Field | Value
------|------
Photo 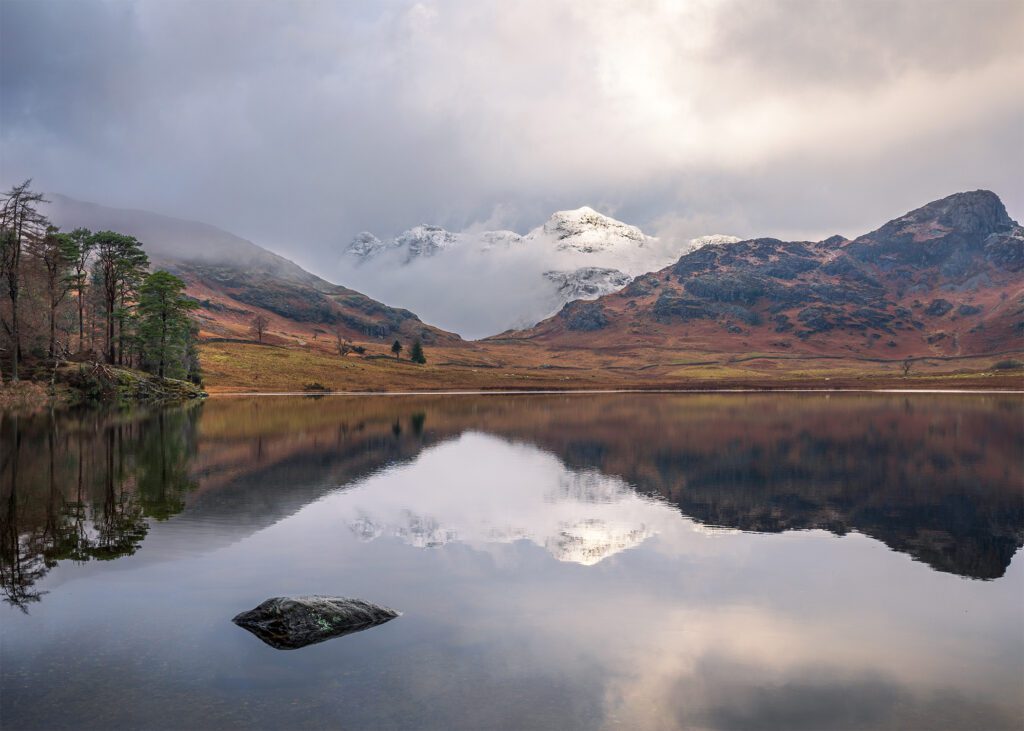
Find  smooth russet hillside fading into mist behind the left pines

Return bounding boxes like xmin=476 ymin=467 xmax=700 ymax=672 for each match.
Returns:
xmin=46 ymin=196 xmax=461 ymax=343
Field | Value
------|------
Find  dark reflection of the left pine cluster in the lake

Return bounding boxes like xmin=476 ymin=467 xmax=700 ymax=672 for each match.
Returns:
xmin=0 ymin=405 xmax=202 ymax=611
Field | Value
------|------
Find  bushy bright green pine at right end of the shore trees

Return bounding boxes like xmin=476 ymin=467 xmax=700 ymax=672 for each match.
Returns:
xmin=137 ymin=270 xmax=197 ymax=378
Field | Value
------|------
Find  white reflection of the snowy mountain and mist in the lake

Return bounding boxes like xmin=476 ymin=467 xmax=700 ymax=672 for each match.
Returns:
xmin=346 ymin=432 xmax=663 ymax=566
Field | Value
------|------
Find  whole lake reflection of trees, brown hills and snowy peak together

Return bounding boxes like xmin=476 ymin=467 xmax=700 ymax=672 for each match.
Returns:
xmin=0 ymin=394 xmax=1024 ymax=606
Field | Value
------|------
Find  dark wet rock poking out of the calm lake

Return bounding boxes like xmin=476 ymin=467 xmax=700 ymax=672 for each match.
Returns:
xmin=231 ymin=597 xmax=399 ymax=650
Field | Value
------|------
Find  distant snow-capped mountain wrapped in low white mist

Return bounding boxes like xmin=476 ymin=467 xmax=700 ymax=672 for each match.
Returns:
xmin=343 ymin=206 xmax=738 ymax=334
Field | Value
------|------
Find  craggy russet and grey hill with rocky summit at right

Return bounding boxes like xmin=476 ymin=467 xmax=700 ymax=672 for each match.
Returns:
xmin=504 ymin=190 xmax=1024 ymax=358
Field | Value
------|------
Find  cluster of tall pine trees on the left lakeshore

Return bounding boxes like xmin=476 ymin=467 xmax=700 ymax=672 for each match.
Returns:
xmin=0 ymin=180 xmax=200 ymax=382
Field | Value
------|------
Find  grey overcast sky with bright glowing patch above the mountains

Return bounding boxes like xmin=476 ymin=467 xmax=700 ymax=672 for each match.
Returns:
xmin=0 ymin=0 xmax=1024 ymax=274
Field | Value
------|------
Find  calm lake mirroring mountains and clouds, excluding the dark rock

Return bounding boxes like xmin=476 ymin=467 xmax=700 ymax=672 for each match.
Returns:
xmin=0 ymin=393 xmax=1024 ymax=730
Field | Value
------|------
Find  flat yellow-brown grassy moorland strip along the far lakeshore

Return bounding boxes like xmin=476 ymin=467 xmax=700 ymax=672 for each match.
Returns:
xmin=200 ymin=341 xmax=1024 ymax=393
